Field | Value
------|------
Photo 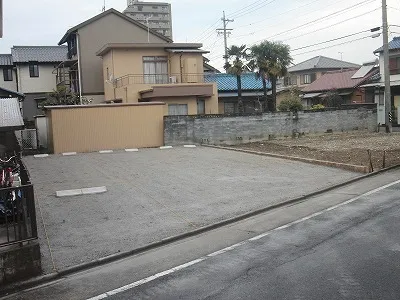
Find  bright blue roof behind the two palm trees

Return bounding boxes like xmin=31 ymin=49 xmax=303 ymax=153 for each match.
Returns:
xmin=204 ymin=73 xmax=271 ymax=92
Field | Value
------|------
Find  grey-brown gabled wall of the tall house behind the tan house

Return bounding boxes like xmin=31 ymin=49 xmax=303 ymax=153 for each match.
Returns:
xmin=78 ymin=14 xmax=166 ymax=95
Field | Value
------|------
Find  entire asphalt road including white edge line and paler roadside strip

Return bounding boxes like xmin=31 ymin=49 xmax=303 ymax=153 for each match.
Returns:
xmin=5 ymin=171 xmax=400 ymax=300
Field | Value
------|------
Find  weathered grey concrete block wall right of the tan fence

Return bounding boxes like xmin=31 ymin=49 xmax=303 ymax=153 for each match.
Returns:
xmin=164 ymin=108 xmax=377 ymax=145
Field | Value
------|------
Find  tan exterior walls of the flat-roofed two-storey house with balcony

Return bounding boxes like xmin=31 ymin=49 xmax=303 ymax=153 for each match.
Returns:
xmin=103 ymin=49 xmax=218 ymax=114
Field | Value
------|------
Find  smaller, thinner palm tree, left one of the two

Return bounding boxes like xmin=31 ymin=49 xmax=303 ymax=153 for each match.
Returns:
xmin=224 ymin=45 xmax=249 ymax=113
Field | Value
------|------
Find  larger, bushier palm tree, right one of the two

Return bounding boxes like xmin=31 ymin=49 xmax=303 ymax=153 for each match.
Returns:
xmin=251 ymin=41 xmax=293 ymax=111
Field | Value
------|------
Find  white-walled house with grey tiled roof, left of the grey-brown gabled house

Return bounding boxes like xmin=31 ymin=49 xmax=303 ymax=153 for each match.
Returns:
xmin=11 ymin=46 xmax=67 ymax=121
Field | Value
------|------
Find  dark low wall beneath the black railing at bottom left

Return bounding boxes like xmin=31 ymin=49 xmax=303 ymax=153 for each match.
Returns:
xmin=0 ymin=241 xmax=42 ymax=286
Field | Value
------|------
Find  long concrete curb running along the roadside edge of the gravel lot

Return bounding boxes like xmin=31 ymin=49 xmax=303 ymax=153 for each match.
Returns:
xmin=0 ymin=165 xmax=400 ymax=297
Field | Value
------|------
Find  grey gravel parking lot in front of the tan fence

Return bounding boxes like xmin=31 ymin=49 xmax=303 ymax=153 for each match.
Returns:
xmin=24 ymin=147 xmax=358 ymax=273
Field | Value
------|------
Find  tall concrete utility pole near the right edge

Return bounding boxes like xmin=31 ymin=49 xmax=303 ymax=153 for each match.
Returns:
xmin=382 ymin=0 xmax=392 ymax=133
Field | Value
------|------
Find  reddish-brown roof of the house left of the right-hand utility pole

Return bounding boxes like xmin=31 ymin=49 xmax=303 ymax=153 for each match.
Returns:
xmin=302 ymin=68 xmax=378 ymax=93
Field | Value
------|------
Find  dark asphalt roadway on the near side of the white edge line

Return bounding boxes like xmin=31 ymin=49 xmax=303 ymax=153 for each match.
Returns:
xmin=101 ymin=180 xmax=400 ymax=300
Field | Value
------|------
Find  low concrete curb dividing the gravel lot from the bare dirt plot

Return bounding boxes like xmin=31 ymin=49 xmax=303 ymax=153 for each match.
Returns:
xmin=202 ymin=145 xmax=369 ymax=174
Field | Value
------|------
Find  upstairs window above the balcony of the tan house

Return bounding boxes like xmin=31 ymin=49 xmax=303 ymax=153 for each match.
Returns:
xmin=143 ymin=56 xmax=168 ymax=83
